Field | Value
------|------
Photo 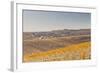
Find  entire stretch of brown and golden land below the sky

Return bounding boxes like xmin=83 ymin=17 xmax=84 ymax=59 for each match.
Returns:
xmin=23 ymin=29 xmax=91 ymax=62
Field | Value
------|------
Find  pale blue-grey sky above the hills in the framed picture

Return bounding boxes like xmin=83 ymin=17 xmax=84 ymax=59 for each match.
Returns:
xmin=23 ymin=10 xmax=91 ymax=32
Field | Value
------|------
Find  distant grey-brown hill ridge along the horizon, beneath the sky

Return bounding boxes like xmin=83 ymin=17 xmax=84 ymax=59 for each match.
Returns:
xmin=23 ymin=29 xmax=91 ymax=38
